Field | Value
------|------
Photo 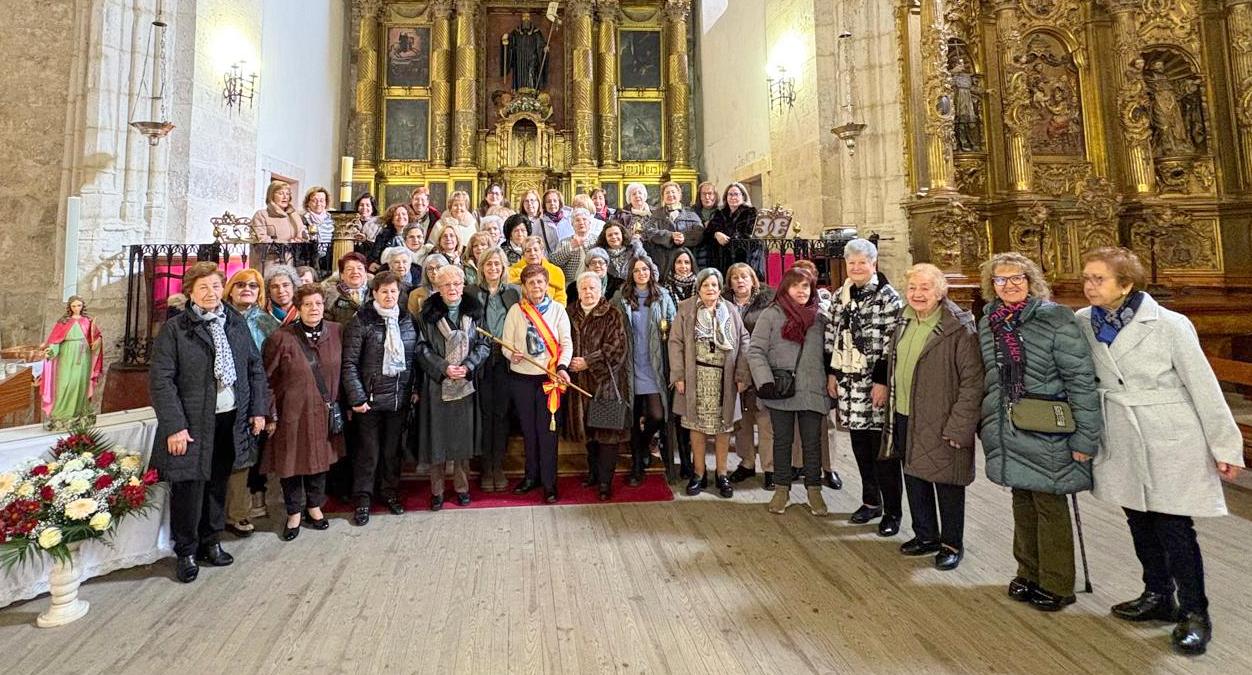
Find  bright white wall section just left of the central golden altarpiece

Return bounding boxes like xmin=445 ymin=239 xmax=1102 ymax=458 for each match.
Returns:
xmin=255 ymin=0 xmax=349 ymax=207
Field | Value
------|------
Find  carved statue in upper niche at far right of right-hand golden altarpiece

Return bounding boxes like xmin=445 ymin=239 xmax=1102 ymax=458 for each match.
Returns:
xmin=1143 ymin=60 xmax=1208 ymax=157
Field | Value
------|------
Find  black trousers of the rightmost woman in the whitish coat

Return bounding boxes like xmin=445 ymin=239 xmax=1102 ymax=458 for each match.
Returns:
xmin=1123 ymin=508 xmax=1208 ymax=612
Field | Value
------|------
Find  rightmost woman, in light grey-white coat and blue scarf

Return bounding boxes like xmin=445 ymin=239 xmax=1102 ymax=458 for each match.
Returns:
xmin=1078 ymin=248 xmax=1243 ymax=655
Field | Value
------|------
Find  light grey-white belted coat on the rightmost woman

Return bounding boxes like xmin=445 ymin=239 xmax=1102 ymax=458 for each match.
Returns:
xmin=1078 ymin=294 xmax=1243 ymax=517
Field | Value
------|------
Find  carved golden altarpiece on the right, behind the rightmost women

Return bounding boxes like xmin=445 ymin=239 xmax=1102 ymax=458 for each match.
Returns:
xmin=896 ymin=0 xmax=1252 ymax=348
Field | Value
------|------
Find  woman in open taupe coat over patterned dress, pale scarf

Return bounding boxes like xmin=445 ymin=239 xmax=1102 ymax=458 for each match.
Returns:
xmin=669 ymin=268 xmax=751 ymax=498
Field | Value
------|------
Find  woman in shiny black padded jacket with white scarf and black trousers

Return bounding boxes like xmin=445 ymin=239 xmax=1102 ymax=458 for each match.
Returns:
xmin=342 ymin=272 xmax=417 ymax=526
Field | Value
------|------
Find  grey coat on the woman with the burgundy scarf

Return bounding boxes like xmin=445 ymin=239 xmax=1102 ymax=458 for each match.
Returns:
xmin=747 ymin=304 xmax=830 ymax=415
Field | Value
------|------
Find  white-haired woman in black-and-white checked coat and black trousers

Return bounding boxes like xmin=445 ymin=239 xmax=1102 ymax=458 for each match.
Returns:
xmin=826 ymin=239 xmax=904 ymax=537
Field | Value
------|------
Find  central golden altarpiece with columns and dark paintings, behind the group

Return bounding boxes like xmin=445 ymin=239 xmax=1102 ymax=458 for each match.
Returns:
xmin=346 ymin=0 xmax=696 ymax=208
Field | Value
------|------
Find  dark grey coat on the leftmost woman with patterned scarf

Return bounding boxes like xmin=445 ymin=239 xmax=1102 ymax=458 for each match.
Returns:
xmin=148 ymin=306 xmax=269 ymax=482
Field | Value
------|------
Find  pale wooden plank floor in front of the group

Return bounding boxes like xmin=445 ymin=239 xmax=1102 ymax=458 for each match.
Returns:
xmin=0 ymin=437 xmax=1252 ymax=675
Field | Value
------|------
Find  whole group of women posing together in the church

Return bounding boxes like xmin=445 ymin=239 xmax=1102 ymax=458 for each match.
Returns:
xmin=151 ymin=184 xmax=1242 ymax=654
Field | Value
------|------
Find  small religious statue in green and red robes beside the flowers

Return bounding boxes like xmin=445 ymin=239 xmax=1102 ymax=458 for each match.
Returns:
xmin=39 ymin=296 xmax=104 ymax=430
